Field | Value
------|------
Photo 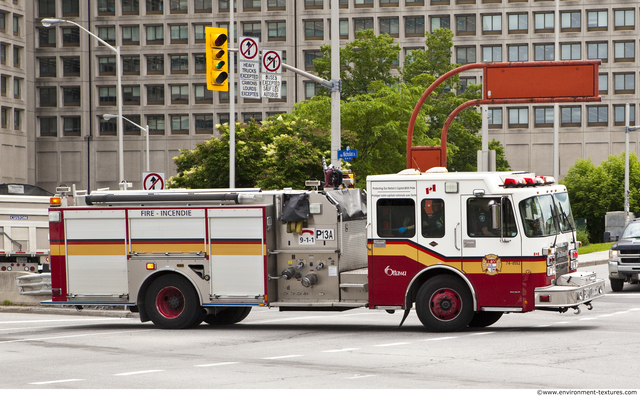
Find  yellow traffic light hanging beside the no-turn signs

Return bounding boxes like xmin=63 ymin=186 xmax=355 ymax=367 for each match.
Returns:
xmin=205 ymin=26 xmax=229 ymax=92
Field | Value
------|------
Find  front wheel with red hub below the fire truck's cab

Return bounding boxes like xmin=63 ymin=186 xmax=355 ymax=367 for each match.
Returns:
xmin=416 ymin=275 xmax=474 ymax=332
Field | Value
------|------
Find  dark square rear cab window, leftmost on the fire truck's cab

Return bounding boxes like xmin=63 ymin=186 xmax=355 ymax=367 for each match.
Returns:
xmin=377 ymin=198 xmax=416 ymax=238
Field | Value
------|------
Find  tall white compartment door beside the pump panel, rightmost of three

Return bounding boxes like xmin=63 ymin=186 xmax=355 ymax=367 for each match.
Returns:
xmin=207 ymin=208 xmax=266 ymax=301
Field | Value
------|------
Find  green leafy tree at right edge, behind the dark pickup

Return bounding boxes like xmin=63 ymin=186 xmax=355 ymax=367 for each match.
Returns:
xmin=560 ymin=153 xmax=640 ymax=242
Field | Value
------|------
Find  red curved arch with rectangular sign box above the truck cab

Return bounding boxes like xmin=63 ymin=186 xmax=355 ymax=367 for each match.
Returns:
xmin=407 ymin=60 xmax=601 ymax=171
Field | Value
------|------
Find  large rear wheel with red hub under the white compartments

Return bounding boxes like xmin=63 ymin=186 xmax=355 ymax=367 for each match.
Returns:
xmin=145 ymin=274 xmax=203 ymax=329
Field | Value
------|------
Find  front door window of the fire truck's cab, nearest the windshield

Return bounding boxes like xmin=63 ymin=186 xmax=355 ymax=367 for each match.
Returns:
xmin=467 ymin=198 xmax=518 ymax=238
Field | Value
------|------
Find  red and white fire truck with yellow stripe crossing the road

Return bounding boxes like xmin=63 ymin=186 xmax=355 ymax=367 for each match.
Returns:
xmin=45 ymin=168 xmax=604 ymax=332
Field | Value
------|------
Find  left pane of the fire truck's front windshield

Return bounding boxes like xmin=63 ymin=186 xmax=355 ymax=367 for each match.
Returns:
xmin=520 ymin=195 xmax=568 ymax=237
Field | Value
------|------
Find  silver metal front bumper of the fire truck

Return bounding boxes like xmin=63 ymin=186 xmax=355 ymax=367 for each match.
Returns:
xmin=534 ymin=274 xmax=604 ymax=310
